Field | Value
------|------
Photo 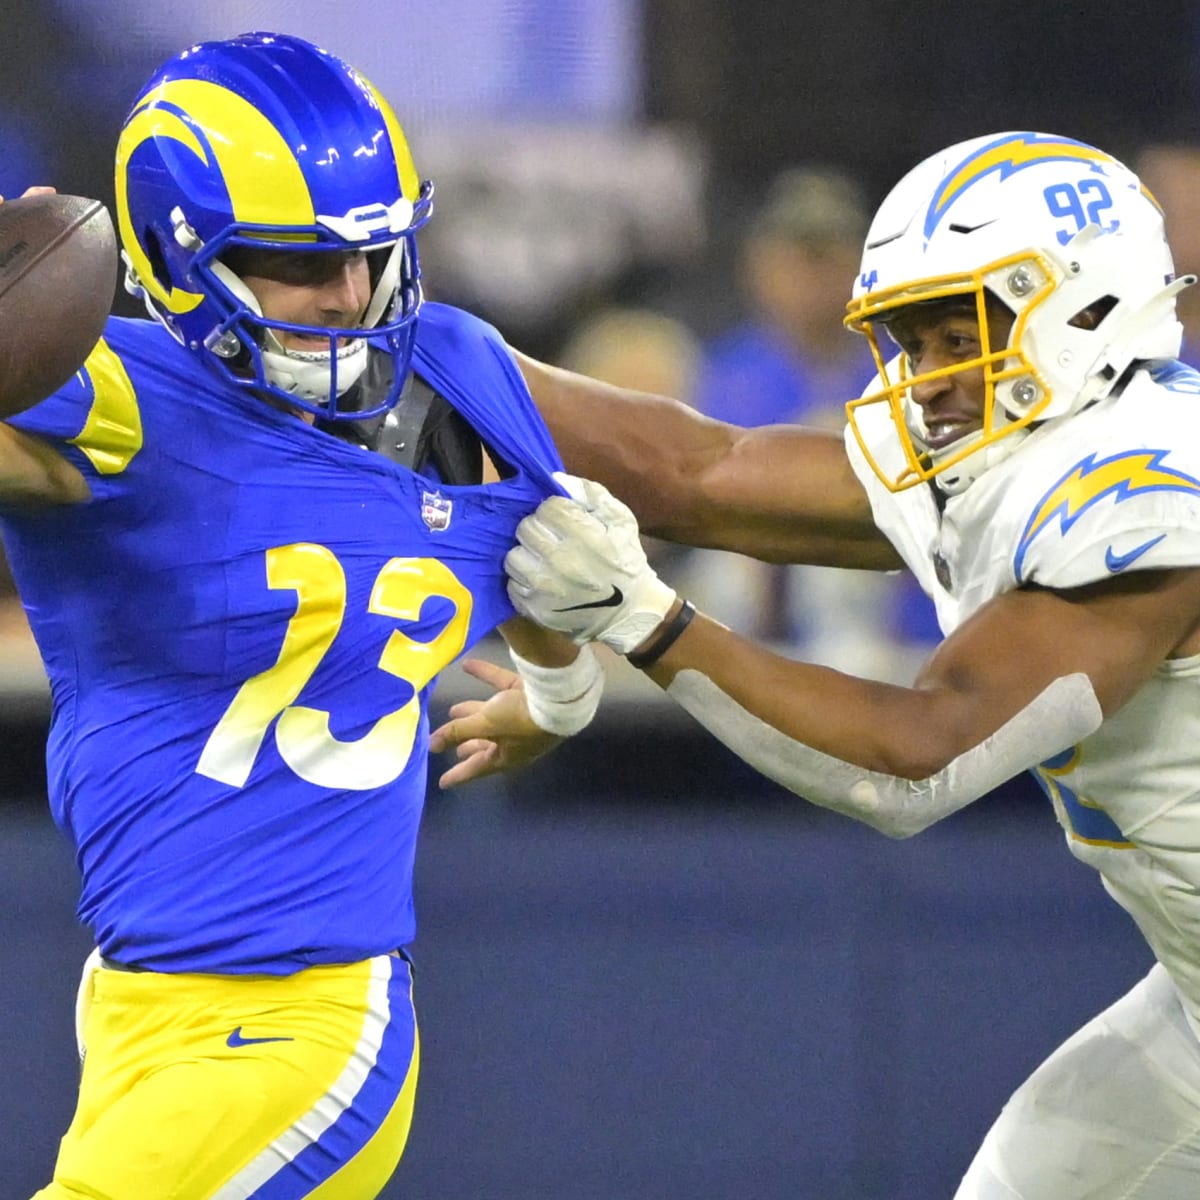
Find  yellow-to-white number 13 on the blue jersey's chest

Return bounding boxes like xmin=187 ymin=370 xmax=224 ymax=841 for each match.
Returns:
xmin=196 ymin=542 xmax=472 ymax=790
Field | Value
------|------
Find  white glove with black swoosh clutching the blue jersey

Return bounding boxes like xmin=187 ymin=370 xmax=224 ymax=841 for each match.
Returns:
xmin=504 ymin=474 xmax=676 ymax=654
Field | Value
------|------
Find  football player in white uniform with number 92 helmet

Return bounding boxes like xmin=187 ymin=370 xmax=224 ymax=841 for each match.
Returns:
xmin=434 ymin=133 xmax=1200 ymax=1200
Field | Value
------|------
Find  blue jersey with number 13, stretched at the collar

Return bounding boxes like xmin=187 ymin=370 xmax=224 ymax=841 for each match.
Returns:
xmin=2 ymin=305 xmax=560 ymax=973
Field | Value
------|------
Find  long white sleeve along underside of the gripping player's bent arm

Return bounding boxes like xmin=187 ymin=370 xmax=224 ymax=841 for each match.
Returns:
xmin=667 ymin=671 xmax=1104 ymax=838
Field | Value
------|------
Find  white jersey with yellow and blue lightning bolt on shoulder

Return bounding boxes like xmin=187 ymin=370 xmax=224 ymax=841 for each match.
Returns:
xmin=846 ymin=362 xmax=1200 ymax=1022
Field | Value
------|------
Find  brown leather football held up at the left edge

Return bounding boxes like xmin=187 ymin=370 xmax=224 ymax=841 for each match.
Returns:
xmin=0 ymin=194 xmax=116 ymax=418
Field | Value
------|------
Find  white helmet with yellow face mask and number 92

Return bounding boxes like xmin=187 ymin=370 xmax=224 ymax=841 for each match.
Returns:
xmin=846 ymin=132 xmax=1195 ymax=494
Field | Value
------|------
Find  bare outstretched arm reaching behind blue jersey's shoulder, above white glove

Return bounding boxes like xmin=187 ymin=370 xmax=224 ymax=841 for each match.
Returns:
xmin=515 ymin=354 xmax=901 ymax=570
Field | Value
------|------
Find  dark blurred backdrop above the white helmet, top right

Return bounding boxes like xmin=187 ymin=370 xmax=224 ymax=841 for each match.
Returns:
xmin=647 ymin=0 xmax=1200 ymax=198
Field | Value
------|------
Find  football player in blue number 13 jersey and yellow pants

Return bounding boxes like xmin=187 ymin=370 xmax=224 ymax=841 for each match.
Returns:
xmin=0 ymin=34 xmax=601 ymax=1200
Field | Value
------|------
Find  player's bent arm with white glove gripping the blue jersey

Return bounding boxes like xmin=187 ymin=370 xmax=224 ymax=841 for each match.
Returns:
xmin=489 ymin=485 xmax=1200 ymax=836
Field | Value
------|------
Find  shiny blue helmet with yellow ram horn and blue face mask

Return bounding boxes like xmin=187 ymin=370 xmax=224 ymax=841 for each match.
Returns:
xmin=116 ymin=34 xmax=432 ymax=420
